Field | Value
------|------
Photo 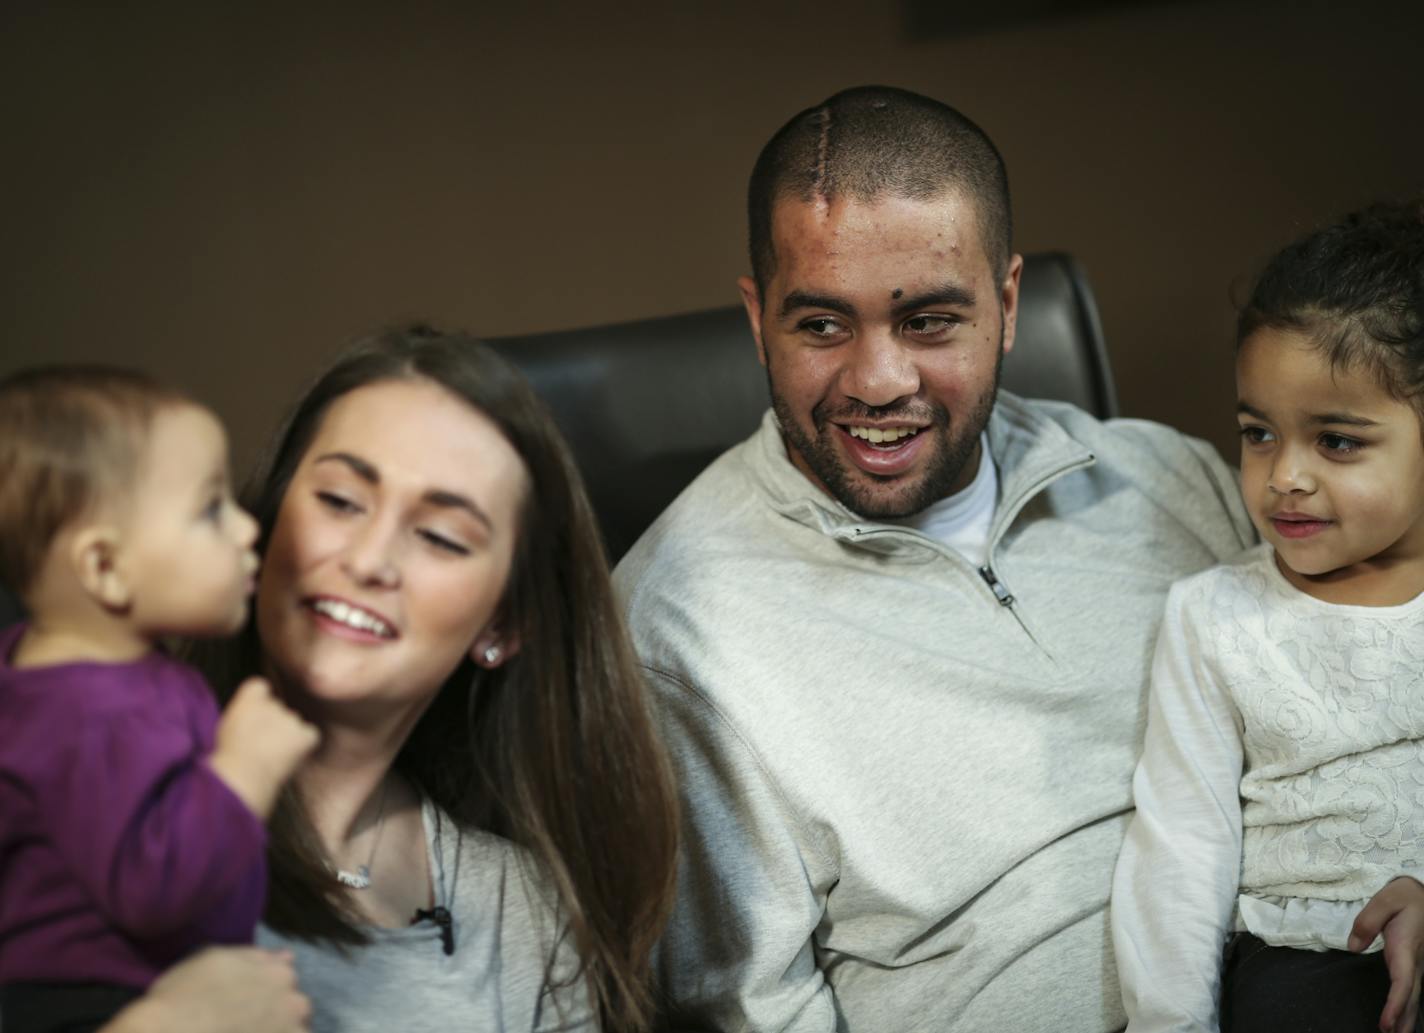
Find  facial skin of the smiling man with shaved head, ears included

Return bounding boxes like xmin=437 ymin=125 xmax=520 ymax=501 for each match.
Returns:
xmin=738 ymin=191 xmax=1022 ymax=519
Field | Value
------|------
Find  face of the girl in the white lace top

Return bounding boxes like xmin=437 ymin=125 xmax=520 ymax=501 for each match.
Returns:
xmin=1236 ymin=331 xmax=1424 ymax=601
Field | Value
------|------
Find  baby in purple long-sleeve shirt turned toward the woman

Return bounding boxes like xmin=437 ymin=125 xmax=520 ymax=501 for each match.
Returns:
xmin=0 ymin=368 xmax=316 ymax=1033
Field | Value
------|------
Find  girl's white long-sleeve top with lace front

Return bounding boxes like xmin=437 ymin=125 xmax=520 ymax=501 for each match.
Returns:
xmin=1112 ymin=546 xmax=1424 ymax=1032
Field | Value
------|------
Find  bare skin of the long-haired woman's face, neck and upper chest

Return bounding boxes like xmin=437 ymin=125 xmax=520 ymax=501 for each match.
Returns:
xmin=256 ymin=380 xmax=528 ymax=928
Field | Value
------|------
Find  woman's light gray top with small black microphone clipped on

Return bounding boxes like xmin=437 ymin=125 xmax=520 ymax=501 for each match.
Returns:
xmin=258 ymin=801 xmax=598 ymax=1033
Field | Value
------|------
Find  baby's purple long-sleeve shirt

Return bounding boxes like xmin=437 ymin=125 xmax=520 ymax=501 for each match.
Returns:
xmin=0 ymin=625 xmax=266 ymax=987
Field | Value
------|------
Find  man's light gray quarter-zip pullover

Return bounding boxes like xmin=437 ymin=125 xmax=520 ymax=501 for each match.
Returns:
xmin=617 ymin=393 xmax=1255 ymax=1033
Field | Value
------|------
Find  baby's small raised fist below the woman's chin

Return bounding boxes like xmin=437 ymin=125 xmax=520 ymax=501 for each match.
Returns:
xmin=208 ymin=678 xmax=320 ymax=821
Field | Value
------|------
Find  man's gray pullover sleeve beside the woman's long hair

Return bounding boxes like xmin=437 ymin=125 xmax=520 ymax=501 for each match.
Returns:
xmin=649 ymin=671 xmax=836 ymax=1033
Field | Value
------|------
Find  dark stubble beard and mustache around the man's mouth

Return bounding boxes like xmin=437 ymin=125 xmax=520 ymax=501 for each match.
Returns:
xmin=766 ymin=346 xmax=1004 ymax=520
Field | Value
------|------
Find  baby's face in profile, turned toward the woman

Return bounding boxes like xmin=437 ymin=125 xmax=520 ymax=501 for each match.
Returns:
xmin=118 ymin=405 xmax=258 ymax=638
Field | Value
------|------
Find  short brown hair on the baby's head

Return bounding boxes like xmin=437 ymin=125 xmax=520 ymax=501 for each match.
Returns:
xmin=0 ymin=366 xmax=192 ymax=597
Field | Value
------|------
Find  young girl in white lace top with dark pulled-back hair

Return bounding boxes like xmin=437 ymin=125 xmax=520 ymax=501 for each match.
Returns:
xmin=1112 ymin=202 xmax=1424 ymax=1033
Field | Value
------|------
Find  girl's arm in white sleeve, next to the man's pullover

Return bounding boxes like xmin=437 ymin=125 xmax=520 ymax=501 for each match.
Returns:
xmin=1111 ymin=586 xmax=1242 ymax=1033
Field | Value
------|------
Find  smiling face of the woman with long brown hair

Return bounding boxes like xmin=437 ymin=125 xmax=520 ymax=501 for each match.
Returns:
xmin=256 ymin=380 xmax=528 ymax=720
